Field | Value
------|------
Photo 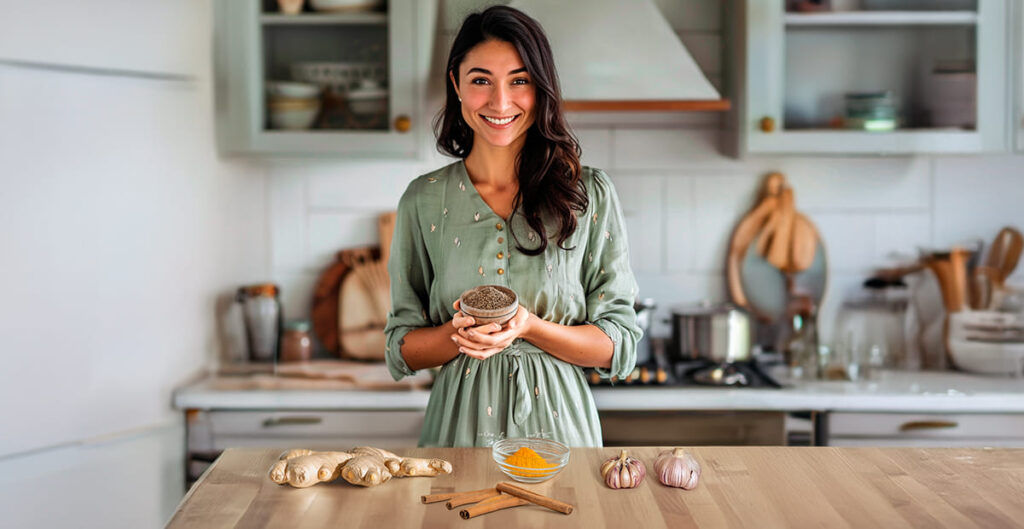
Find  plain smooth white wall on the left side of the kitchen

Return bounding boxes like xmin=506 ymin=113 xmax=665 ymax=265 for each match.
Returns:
xmin=0 ymin=0 xmax=268 ymax=528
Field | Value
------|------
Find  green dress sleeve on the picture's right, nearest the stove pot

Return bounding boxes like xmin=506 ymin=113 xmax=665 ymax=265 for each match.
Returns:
xmin=581 ymin=169 xmax=643 ymax=379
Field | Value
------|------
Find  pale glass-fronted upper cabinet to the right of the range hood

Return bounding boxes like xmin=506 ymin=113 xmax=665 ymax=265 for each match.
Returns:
xmin=730 ymin=0 xmax=1013 ymax=156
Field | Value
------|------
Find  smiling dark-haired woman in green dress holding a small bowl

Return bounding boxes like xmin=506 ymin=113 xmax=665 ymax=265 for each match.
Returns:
xmin=385 ymin=6 xmax=640 ymax=446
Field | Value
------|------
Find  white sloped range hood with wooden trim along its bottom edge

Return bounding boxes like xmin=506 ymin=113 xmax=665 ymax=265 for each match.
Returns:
xmin=509 ymin=0 xmax=729 ymax=112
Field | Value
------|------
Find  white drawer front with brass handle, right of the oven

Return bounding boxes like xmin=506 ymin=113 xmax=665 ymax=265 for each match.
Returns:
xmin=828 ymin=413 xmax=1024 ymax=444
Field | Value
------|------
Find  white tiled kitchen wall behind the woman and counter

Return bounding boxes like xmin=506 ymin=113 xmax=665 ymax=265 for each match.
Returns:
xmin=269 ymin=0 xmax=1024 ymax=340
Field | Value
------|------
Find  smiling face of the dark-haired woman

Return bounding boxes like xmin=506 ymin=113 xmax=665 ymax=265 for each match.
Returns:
xmin=450 ymin=40 xmax=537 ymax=147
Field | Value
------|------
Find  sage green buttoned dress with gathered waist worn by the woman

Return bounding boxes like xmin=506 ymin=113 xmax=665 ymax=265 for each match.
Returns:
xmin=384 ymin=161 xmax=641 ymax=446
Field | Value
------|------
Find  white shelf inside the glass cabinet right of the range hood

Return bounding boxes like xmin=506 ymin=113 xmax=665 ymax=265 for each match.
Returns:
xmin=784 ymin=11 xmax=978 ymax=28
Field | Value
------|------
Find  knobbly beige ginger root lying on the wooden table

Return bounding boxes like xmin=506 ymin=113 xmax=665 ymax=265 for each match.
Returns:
xmin=270 ymin=446 xmax=452 ymax=488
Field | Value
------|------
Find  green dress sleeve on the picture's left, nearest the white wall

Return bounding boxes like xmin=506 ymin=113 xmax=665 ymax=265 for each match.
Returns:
xmin=384 ymin=181 xmax=433 ymax=381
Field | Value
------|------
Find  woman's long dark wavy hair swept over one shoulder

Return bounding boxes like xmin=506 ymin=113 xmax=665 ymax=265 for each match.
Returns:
xmin=434 ymin=5 xmax=588 ymax=256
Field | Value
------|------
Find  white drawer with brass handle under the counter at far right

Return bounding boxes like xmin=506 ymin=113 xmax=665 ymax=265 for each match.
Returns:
xmin=827 ymin=412 xmax=1024 ymax=447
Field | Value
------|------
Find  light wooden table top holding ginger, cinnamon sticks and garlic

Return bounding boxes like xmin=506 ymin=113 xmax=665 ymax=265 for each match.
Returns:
xmin=169 ymin=447 xmax=1024 ymax=529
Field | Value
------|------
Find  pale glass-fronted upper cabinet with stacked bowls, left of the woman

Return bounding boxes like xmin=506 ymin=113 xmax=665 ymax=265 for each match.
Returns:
xmin=214 ymin=0 xmax=425 ymax=158
